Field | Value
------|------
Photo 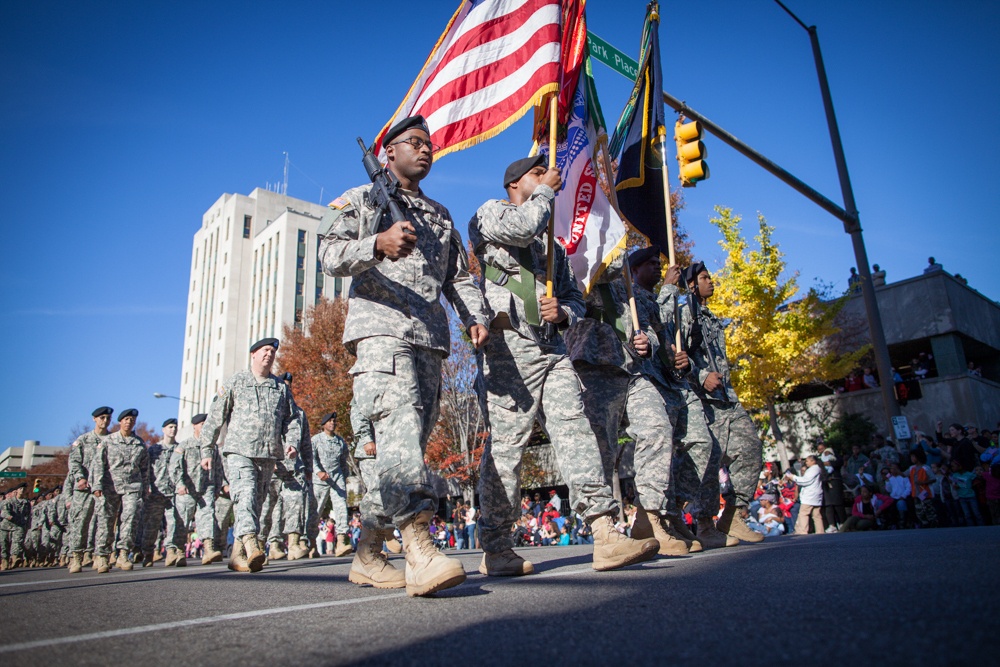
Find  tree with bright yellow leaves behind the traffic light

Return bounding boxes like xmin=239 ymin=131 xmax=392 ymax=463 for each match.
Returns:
xmin=709 ymin=206 xmax=867 ymax=468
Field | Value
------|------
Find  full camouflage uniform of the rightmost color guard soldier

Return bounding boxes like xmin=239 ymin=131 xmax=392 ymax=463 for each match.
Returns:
xmin=681 ymin=294 xmax=764 ymax=507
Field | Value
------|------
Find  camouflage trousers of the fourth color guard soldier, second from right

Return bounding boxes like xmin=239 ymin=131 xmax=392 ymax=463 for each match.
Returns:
xmin=671 ymin=390 xmax=722 ymax=519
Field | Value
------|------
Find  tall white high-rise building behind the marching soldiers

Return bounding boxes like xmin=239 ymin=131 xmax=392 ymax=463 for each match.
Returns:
xmin=178 ymin=188 xmax=349 ymax=431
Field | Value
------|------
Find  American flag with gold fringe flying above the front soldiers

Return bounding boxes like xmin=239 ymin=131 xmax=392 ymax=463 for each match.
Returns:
xmin=375 ymin=0 xmax=560 ymax=157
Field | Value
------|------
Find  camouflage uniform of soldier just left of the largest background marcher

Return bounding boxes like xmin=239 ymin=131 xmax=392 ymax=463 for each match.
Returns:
xmin=167 ymin=438 xmax=216 ymax=552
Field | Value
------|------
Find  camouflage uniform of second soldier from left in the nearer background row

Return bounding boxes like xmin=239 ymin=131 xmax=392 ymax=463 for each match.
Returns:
xmin=92 ymin=431 xmax=149 ymax=556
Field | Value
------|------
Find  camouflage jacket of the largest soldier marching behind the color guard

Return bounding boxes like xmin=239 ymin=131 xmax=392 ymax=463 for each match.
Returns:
xmin=200 ymin=370 xmax=302 ymax=459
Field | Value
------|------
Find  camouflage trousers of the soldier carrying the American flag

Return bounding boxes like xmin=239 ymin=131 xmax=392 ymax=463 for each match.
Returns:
xmin=476 ymin=329 xmax=618 ymax=553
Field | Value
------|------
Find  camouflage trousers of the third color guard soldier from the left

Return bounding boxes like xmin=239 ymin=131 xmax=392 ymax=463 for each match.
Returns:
xmin=576 ymin=363 xmax=674 ymax=514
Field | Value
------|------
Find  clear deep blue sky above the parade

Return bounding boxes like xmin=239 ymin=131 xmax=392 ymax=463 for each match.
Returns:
xmin=0 ymin=0 xmax=1000 ymax=449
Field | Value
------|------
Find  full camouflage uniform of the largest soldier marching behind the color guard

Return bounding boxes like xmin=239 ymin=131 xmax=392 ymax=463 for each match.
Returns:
xmin=201 ymin=370 xmax=301 ymax=537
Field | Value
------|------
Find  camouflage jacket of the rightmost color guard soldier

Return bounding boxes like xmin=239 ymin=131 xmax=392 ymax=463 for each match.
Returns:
xmin=658 ymin=285 xmax=739 ymax=404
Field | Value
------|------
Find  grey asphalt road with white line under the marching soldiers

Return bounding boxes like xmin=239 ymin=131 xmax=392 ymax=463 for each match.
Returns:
xmin=0 ymin=527 xmax=1000 ymax=667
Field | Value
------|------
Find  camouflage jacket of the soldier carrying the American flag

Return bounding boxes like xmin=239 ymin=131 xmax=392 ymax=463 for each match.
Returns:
xmin=469 ymin=185 xmax=586 ymax=347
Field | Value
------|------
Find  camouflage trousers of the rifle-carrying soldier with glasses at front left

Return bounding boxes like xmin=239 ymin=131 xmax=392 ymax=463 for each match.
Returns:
xmin=351 ymin=336 xmax=444 ymax=525
